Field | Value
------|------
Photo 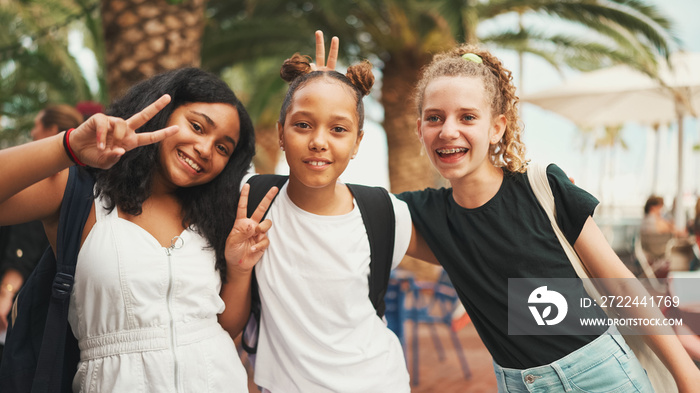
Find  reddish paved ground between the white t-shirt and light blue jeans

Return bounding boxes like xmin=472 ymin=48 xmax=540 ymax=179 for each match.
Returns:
xmin=244 ymin=322 xmax=496 ymax=393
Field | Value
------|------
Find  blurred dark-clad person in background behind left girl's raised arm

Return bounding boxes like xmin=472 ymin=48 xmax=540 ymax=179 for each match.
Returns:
xmin=0 ymin=104 xmax=83 ymax=359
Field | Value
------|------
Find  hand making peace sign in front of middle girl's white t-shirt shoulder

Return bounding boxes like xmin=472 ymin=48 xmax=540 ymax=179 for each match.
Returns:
xmin=225 ymin=184 xmax=278 ymax=273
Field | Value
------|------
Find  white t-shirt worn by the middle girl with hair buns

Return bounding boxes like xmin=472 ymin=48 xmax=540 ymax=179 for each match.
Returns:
xmin=255 ymin=183 xmax=411 ymax=393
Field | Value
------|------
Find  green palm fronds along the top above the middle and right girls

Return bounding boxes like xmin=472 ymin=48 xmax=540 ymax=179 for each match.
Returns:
xmin=202 ymin=0 xmax=678 ymax=135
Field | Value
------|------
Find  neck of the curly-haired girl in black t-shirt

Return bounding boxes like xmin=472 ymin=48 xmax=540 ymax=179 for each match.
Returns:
xmin=450 ymin=165 xmax=503 ymax=209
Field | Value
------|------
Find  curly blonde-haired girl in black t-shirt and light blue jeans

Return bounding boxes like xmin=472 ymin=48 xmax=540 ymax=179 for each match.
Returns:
xmin=398 ymin=45 xmax=700 ymax=392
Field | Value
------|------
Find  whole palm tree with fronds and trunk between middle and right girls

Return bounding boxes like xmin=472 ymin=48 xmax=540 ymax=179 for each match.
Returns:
xmin=205 ymin=0 xmax=674 ymax=192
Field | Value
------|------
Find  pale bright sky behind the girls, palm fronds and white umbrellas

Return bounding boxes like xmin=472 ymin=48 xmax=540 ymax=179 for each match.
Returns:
xmin=334 ymin=0 xmax=700 ymax=217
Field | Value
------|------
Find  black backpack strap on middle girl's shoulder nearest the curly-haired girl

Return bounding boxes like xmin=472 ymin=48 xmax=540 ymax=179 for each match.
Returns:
xmin=347 ymin=184 xmax=396 ymax=317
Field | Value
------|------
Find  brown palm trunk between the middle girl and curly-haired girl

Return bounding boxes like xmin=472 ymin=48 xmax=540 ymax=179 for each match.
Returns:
xmin=381 ymin=51 xmax=438 ymax=193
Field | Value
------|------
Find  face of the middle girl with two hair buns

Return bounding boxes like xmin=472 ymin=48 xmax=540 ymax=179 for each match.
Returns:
xmin=277 ymin=78 xmax=362 ymax=188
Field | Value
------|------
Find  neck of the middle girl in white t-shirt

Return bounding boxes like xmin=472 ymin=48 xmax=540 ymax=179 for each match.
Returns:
xmin=287 ymin=176 xmax=353 ymax=216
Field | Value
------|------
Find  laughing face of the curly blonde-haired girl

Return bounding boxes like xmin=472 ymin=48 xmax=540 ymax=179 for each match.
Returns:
xmin=417 ymin=77 xmax=506 ymax=181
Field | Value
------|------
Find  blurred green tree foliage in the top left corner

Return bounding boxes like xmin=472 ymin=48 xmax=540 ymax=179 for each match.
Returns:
xmin=0 ymin=0 xmax=99 ymax=147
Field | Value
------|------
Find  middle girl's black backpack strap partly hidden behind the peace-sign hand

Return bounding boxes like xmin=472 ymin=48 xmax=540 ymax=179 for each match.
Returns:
xmin=241 ymin=175 xmax=288 ymax=355
